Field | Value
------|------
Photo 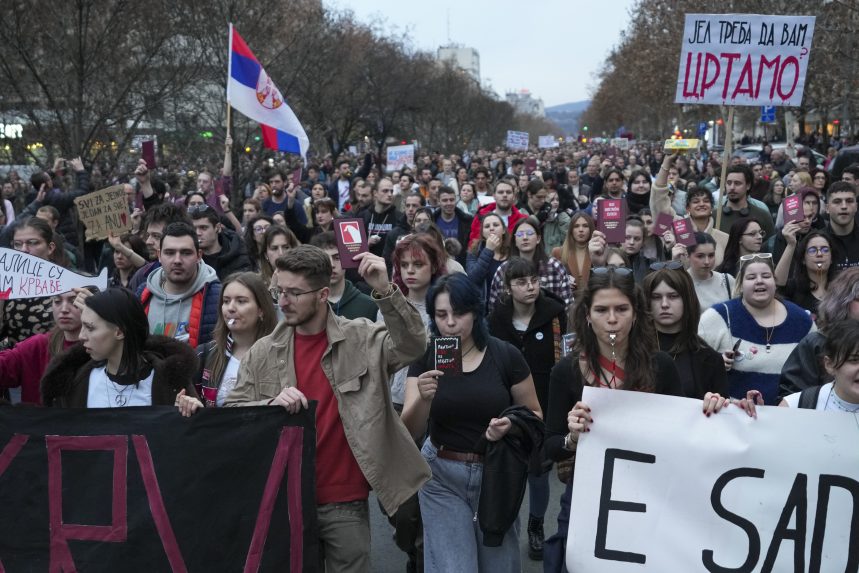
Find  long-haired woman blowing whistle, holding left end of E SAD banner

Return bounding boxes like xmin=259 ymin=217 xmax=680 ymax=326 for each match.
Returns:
xmin=544 ymin=267 xmax=682 ymax=571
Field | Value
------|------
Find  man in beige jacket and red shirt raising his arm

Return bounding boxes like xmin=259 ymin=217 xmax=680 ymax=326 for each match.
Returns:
xmin=225 ymin=245 xmax=430 ymax=573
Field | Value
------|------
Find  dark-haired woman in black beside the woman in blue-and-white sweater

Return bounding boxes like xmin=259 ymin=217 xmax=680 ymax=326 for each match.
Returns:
xmin=642 ymin=268 xmax=728 ymax=399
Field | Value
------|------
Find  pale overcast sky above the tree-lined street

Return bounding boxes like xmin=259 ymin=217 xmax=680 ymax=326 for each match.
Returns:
xmin=324 ymin=0 xmax=633 ymax=107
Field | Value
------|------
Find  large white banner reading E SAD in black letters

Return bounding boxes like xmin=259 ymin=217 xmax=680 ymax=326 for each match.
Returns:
xmin=566 ymin=387 xmax=859 ymax=573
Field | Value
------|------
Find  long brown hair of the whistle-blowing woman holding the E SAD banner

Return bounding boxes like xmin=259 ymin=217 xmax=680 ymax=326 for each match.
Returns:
xmin=573 ymin=269 xmax=658 ymax=392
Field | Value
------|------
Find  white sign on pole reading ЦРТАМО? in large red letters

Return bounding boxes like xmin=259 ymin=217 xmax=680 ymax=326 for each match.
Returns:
xmin=674 ymin=14 xmax=815 ymax=107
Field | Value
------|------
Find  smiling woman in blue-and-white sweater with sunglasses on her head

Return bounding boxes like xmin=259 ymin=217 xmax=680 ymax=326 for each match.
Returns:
xmin=698 ymin=253 xmax=816 ymax=405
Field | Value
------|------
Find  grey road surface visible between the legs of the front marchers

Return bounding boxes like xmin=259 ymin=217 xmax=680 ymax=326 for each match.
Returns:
xmin=370 ymin=474 xmax=564 ymax=573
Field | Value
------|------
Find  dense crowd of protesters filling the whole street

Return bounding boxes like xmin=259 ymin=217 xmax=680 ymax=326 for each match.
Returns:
xmin=0 ymin=135 xmax=859 ymax=572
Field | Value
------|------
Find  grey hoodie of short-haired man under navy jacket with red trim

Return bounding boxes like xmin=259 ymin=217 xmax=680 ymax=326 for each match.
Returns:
xmin=143 ymin=261 xmax=221 ymax=344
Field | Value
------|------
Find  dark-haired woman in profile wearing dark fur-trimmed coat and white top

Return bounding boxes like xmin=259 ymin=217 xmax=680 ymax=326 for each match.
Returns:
xmin=42 ymin=288 xmax=197 ymax=408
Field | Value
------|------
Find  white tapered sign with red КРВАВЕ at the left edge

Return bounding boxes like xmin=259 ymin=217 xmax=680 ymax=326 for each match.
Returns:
xmin=0 ymin=248 xmax=107 ymax=300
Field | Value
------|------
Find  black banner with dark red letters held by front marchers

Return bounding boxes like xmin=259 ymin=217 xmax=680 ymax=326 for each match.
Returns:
xmin=0 ymin=404 xmax=318 ymax=573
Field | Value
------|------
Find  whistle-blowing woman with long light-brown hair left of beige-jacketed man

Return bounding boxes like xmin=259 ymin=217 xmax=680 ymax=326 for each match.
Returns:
xmin=177 ymin=272 xmax=277 ymax=416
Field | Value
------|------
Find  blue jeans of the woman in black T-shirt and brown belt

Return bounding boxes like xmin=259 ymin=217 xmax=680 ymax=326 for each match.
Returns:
xmin=419 ymin=440 xmax=522 ymax=573
